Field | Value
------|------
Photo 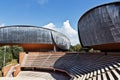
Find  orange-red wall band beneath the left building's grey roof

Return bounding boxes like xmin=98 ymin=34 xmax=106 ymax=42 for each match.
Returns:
xmin=0 ymin=43 xmax=54 ymax=51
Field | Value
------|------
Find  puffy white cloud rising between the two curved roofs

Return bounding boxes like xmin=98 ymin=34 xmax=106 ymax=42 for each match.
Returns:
xmin=43 ymin=20 xmax=79 ymax=45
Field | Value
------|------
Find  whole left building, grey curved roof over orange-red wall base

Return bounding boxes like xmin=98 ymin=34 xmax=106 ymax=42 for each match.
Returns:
xmin=0 ymin=25 xmax=70 ymax=51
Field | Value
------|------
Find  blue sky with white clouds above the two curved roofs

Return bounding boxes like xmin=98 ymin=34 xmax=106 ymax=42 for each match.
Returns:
xmin=0 ymin=0 xmax=116 ymax=45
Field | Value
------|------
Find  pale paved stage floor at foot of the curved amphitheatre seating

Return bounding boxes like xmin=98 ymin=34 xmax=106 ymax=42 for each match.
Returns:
xmin=0 ymin=71 xmax=70 ymax=80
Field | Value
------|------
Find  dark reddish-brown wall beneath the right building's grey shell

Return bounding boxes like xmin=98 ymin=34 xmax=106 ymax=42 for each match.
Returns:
xmin=91 ymin=43 xmax=120 ymax=51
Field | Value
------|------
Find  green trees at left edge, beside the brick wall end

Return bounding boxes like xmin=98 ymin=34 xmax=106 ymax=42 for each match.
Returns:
xmin=0 ymin=45 xmax=23 ymax=69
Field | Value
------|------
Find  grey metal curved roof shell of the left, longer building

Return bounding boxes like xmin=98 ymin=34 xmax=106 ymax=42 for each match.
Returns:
xmin=0 ymin=25 xmax=70 ymax=50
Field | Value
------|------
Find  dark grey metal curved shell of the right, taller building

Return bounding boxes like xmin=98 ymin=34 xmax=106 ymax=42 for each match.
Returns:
xmin=78 ymin=1 xmax=120 ymax=50
